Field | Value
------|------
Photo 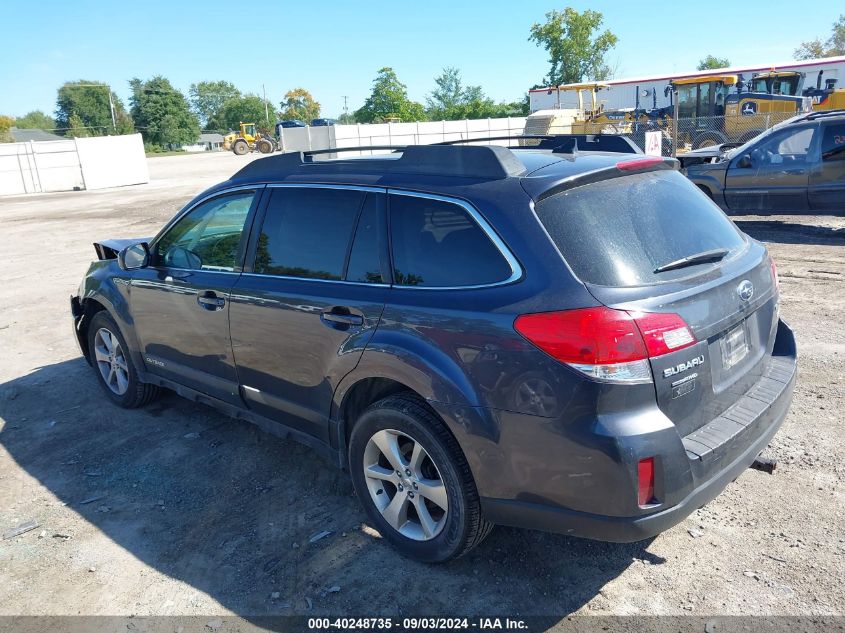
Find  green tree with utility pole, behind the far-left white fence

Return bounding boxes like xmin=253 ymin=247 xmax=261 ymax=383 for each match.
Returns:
xmin=56 ymin=79 xmax=134 ymax=136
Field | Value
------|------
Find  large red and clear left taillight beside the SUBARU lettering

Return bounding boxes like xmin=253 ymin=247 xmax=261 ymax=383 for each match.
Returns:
xmin=514 ymin=306 xmax=696 ymax=382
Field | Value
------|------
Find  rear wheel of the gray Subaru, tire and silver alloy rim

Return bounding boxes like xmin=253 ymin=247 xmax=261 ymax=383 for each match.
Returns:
xmin=349 ymin=393 xmax=493 ymax=563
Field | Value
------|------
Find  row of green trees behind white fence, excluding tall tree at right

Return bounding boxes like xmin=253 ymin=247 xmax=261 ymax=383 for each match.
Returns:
xmin=0 ymin=67 xmax=528 ymax=151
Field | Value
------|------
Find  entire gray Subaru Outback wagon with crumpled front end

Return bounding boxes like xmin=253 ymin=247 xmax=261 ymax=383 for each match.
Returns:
xmin=71 ymin=136 xmax=796 ymax=561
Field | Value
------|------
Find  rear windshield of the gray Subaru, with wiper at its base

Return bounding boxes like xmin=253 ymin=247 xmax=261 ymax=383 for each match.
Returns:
xmin=536 ymin=171 xmax=745 ymax=287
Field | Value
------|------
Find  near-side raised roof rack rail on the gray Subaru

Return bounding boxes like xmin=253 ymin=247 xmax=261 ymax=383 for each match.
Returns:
xmin=232 ymin=145 xmax=525 ymax=180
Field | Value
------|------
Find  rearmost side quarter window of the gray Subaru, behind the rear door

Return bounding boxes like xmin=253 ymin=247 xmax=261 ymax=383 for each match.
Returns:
xmin=390 ymin=194 xmax=512 ymax=288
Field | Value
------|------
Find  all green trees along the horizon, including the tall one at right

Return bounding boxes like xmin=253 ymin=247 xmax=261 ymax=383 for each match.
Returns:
xmin=0 ymin=7 xmax=845 ymax=150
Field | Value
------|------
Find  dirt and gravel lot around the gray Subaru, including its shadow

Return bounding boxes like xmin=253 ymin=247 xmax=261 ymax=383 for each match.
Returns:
xmin=0 ymin=153 xmax=845 ymax=616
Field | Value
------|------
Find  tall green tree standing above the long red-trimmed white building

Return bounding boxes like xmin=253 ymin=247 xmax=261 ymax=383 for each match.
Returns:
xmin=528 ymin=7 xmax=618 ymax=86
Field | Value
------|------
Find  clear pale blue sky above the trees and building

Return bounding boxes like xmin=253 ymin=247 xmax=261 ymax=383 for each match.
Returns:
xmin=0 ymin=0 xmax=843 ymax=123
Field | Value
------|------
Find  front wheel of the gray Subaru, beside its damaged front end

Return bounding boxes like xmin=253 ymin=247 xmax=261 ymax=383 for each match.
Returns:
xmin=88 ymin=310 xmax=159 ymax=409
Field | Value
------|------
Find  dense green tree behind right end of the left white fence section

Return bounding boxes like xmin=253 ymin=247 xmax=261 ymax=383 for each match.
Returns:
xmin=129 ymin=75 xmax=200 ymax=147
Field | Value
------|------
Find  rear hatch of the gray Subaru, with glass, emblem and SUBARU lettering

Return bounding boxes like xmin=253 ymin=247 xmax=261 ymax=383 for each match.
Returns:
xmin=535 ymin=165 xmax=778 ymax=435
